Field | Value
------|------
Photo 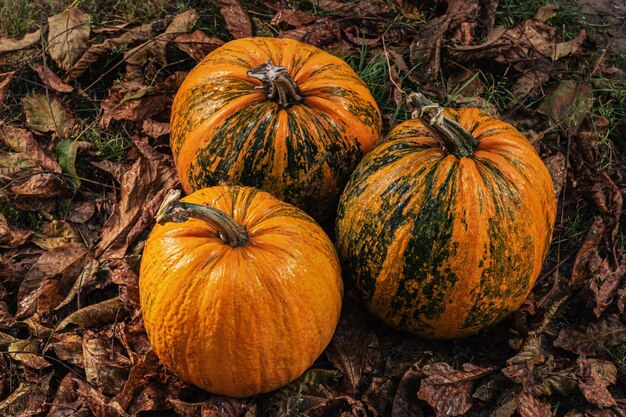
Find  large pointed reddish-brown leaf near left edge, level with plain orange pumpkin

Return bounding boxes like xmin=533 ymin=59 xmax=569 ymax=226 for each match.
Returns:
xmin=15 ymin=243 xmax=87 ymax=319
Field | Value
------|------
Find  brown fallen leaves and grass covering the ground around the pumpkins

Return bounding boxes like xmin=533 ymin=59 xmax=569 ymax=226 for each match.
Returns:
xmin=0 ymin=0 xmax=626 ymax=417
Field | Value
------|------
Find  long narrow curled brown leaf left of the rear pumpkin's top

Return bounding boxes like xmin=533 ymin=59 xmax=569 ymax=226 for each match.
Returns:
xmin=67 ymin=22 xmax=158 ymax=79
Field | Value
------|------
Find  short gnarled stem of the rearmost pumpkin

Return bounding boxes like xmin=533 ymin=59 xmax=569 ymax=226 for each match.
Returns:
xmin=246 ymin=61 xmax=302 ymax=107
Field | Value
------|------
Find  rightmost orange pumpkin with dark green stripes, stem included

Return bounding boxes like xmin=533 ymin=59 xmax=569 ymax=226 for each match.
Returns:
xmin=336 ymin=94 xmax=556 ymax=339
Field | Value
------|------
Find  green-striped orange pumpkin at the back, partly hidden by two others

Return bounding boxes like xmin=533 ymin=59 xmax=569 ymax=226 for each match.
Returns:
xmin=170 ymin=38 xmax=381 ymax=220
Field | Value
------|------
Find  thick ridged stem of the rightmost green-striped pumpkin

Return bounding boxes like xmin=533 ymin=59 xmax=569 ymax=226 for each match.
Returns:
xmin=407 ymin=93 xmax=478 ymax=158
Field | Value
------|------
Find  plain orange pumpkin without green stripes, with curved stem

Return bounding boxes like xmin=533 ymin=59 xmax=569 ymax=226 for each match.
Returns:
xmin=139 ymin=186 xmax=343 ymax=397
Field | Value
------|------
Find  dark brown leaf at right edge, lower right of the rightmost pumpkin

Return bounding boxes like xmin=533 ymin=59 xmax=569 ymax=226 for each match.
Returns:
xmin=554 ymin=314 xmax=626 ymax=356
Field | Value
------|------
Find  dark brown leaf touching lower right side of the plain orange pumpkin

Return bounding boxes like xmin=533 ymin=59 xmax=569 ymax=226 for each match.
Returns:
xmin=326 ymin=304 xmax=381 ymax=395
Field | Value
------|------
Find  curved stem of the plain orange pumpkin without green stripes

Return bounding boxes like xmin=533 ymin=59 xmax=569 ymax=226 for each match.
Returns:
xmin=155 ymin=190 xmax=249 ymax=248
